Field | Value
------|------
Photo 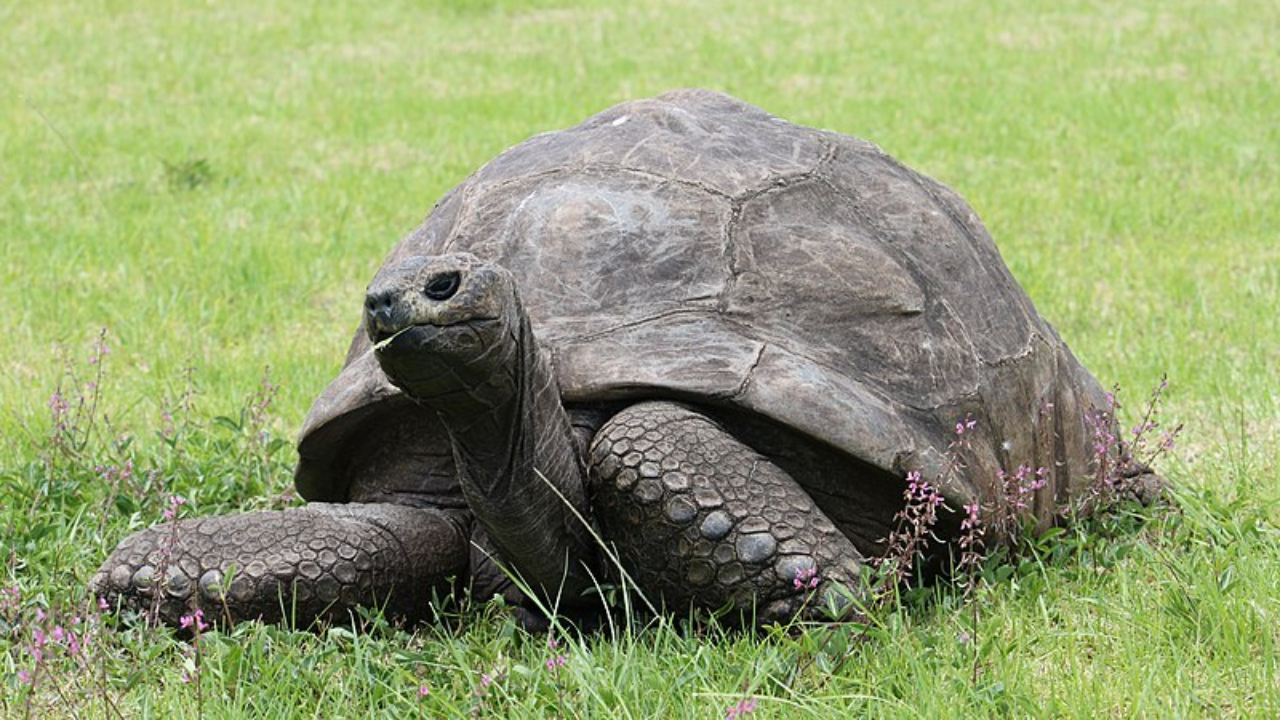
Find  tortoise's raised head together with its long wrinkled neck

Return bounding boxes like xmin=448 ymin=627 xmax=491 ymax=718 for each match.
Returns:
xmin=365 ymin=254 xmax=596 ymax=605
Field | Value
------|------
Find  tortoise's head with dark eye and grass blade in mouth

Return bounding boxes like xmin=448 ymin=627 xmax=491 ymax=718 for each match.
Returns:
xmin=365 ymin=254 xmax=526 ymax=411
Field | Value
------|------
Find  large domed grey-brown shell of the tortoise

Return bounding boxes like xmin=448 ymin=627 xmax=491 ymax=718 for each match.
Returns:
xmin=297 ymin=90 xmax=1105 ymax=519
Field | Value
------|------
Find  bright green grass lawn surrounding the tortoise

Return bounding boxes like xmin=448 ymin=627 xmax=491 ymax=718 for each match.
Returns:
xmin=0 ymin=0 xmax=1280 ymax=717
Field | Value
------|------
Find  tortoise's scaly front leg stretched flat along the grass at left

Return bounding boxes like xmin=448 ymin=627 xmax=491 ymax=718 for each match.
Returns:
xmin=90 ymin=503 xmax=468 ymax=626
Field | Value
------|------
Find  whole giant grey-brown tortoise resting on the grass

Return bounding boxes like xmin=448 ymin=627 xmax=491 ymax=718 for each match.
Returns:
xmin=92 ymin=90 xmax=1126 ymax=621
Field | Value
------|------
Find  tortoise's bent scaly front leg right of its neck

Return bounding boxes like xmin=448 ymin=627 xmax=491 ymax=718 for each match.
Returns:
xmin=589 ymin=402 xmax=863 ymax=624
